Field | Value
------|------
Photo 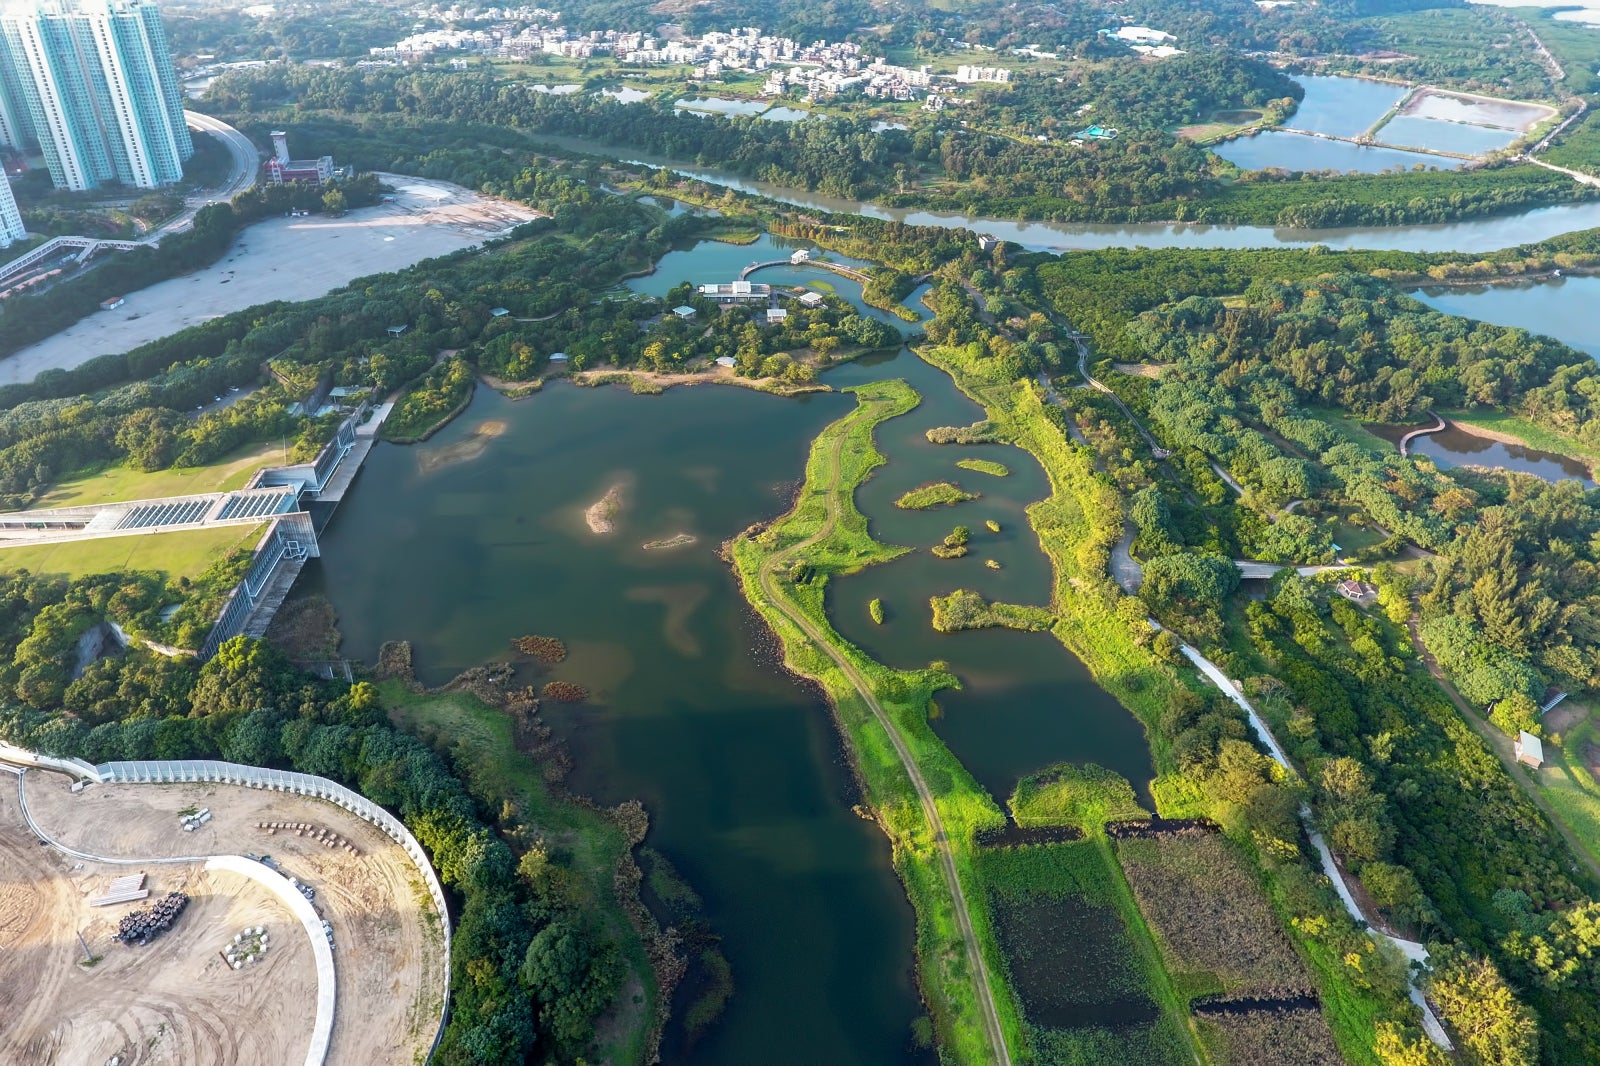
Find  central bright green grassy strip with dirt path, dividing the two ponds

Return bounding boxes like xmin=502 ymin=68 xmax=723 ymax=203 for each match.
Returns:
xmin=730 ymin=381 xmax=1024 ymax=1063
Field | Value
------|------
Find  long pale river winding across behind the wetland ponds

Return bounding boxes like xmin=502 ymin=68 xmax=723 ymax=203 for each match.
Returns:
xmin=521 ymin=134 xmax=1600 ymax=253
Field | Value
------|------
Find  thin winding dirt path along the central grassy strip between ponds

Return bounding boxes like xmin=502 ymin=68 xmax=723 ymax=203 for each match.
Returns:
xmin=758 ymin=419 xmax=1011 ymax=1066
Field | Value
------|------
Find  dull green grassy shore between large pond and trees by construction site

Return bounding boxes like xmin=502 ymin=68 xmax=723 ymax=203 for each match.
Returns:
xmin=378 ymin=680 xmax=656 ymax=1063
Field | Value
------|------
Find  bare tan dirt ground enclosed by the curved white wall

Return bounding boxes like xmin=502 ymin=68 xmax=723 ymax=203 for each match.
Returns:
xmin=12 ymin=771 xmax=446 ymax=1066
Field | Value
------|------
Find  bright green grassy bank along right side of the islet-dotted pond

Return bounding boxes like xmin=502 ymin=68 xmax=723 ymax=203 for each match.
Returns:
xmin=918 ymin=347 xmax=1392 ymax=1064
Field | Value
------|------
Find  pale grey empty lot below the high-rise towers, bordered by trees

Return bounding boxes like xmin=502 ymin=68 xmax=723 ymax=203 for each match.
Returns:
xmin=0 ymin=174 xmax=538 ymax=384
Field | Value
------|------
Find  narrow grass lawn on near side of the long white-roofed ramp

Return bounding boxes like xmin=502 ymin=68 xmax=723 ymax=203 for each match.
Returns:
xmin=0 ymin=525 xmax=266 ymax=578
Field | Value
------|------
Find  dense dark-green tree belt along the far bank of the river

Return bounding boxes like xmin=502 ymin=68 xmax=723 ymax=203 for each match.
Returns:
xmin=193 ymin=51 xmax=1595 ymax=227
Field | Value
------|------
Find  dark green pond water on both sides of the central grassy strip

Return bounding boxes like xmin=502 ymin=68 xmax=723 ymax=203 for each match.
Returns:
xmin=322 ymin=245 xmax=1150 ymax=1064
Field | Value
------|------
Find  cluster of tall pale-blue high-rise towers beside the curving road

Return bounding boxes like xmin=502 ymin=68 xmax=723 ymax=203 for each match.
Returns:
xmin=0 ymin=0 xmax=194 ymax=189
